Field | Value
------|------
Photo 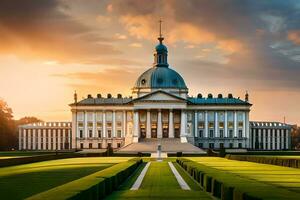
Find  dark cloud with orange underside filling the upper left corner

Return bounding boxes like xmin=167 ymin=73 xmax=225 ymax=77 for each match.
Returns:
xmin=0 ymin=0 xmax=121 ymax=63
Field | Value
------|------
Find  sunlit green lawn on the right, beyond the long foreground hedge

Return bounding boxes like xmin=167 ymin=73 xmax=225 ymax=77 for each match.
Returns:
xmin=189 ymin=157 xmax=300 ymax=199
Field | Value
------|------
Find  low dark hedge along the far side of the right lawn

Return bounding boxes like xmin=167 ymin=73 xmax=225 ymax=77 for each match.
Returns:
xmin=225 ymin=154 xmax=300 ymax=168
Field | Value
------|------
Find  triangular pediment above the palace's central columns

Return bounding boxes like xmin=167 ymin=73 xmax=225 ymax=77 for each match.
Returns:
xmin=133 ymin=91 xmax=186 ymax=102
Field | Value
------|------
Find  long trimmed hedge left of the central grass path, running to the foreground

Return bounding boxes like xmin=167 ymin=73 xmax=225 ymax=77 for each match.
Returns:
xmin=27 ymin=158 xmax=142 ymax=200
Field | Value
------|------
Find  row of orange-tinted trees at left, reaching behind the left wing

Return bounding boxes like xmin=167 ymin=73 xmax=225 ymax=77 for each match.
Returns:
xmin=0 ymin=99 xmax=42 ymax=151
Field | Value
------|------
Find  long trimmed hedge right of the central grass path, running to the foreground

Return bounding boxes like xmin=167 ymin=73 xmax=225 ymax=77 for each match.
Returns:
xmin=176 ymin=158 xmax=299 ymax=200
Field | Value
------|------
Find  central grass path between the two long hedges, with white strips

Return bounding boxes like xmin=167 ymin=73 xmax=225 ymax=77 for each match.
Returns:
xmin=107 ymin=161 xmax=211 ymax=199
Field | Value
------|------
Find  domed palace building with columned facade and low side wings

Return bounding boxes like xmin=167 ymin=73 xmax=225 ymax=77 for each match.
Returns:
xmin=19 ymin=28 xmax=290 ymax=150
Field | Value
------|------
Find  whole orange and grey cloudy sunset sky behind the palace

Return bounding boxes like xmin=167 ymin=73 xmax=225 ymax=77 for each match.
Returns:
xmin=0 ymin=0 xmax=300 ymax=124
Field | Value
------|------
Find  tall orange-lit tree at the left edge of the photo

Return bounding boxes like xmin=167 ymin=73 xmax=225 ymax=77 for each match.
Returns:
xmin=0 ymin=99 xmax=17 ymax=150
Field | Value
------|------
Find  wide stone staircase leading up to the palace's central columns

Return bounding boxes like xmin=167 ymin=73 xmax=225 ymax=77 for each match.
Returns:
xmin=118 ymin=138 xmax=206 ymax=154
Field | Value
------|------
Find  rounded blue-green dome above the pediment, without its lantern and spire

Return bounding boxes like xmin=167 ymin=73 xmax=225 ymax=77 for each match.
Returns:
xmin=134 ymin=67 xmax=187 ymax=89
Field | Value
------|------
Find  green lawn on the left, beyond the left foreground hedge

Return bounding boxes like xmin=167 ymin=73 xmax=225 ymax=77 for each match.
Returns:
xmin=0 ymin=157 xmax=130 ymax=200
